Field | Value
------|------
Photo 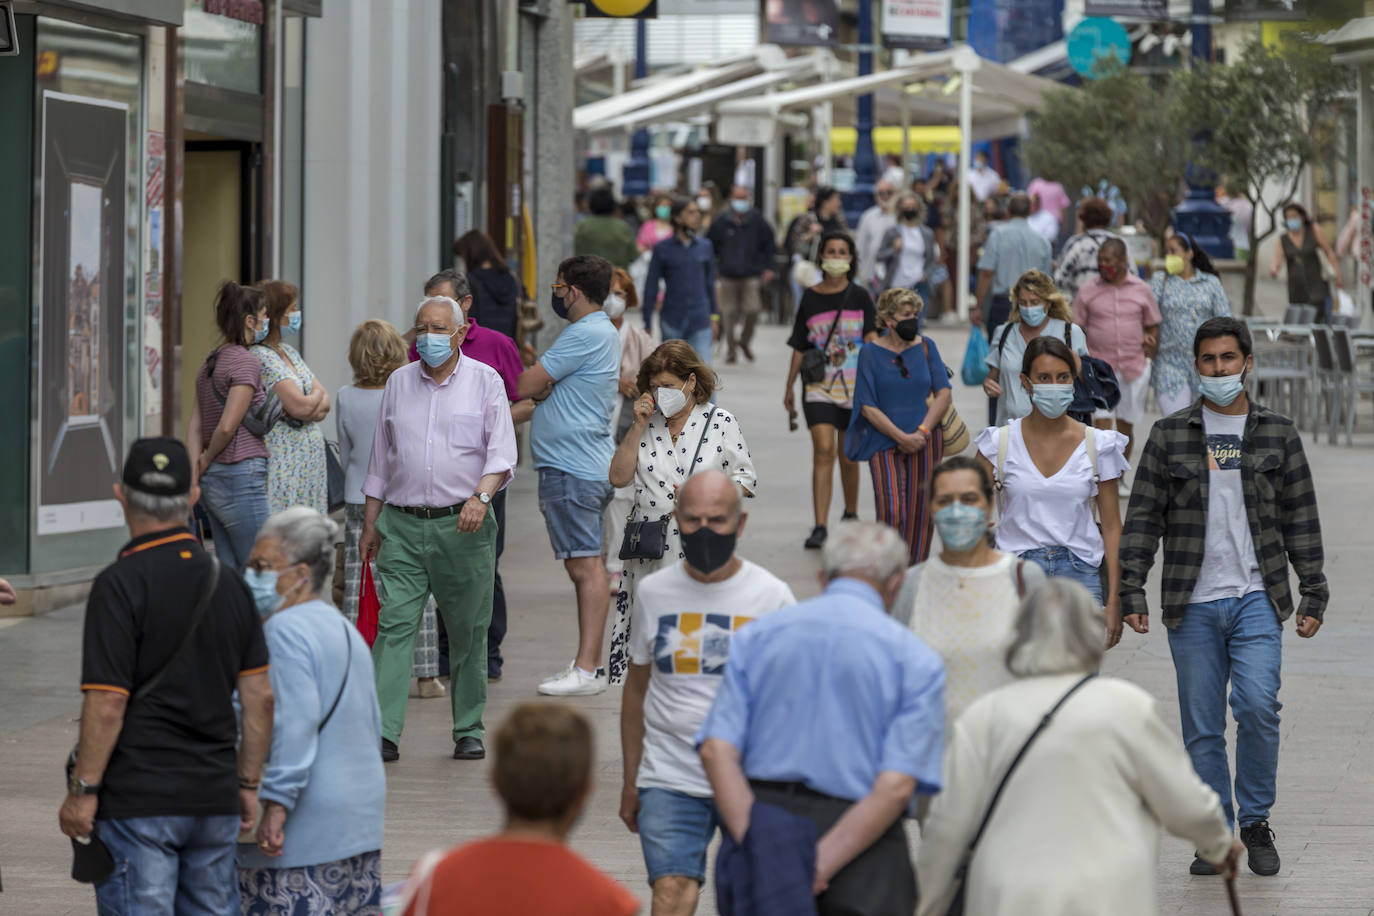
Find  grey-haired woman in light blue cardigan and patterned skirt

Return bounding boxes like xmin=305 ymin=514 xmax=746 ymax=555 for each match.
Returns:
xmin=239 ymin=505 xmax=386 ymax=916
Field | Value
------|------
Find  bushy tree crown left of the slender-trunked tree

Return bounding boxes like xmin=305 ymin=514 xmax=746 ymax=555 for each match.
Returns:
xmin=1024 ymin=65 xmax=1189 ymax=236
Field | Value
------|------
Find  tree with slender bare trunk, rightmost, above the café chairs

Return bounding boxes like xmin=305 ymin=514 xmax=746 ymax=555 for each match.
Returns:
xmin=1172 ymin=37 xmax=1355 ymax=314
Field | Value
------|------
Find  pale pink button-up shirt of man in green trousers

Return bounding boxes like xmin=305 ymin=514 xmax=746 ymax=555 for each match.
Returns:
xmin=363 ymin=356 xmax=515 ymax=508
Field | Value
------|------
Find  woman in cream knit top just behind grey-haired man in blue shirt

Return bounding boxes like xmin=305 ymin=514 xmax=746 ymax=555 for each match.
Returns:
xmin=892 ymin=455 xmax=1046 ymax=736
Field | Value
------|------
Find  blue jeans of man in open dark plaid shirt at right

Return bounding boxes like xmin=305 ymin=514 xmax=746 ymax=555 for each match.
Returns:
xmin=1169 ymin=592 xmax=1283 ymax=827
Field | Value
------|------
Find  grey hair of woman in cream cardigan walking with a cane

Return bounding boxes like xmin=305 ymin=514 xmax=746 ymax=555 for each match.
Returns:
xmin=1007 ymin=578 xmax=1107 ymax=677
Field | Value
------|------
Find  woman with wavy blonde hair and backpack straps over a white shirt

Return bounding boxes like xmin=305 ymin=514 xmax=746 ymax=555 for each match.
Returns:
xmin=982 ymin=271 xmax=1088 ymax=426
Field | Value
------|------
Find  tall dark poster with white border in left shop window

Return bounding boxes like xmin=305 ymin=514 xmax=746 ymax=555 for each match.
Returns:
xmin=36 ymin=92 xmax=129 ymax=534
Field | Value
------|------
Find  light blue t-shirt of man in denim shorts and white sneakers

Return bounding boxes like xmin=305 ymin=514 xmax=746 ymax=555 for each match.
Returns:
xmin=529 ymin=309 xmax=620 ymax=481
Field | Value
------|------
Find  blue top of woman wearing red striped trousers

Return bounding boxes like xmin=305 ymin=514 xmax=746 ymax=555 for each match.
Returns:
xmin=845 ymin=331 xmax=949 ymax=461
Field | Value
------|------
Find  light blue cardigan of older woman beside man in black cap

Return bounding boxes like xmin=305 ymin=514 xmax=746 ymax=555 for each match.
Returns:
xmin=239 ymin=599 xmax=386 ymax=868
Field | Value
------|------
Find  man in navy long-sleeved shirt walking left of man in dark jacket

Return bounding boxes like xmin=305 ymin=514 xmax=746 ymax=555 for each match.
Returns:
xmin=644 ymin=198 xmax=720 ymax=365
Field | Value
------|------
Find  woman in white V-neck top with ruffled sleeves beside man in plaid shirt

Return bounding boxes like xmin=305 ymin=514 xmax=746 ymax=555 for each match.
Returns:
xmin=977 ymin=336 xmax=1129 ymax=648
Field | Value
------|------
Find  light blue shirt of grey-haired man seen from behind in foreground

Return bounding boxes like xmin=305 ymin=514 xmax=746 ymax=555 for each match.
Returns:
xmin=697 ymin=578 xmax=944 ymax=801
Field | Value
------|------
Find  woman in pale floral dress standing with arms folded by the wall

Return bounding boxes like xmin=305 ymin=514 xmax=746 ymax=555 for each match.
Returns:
xmin=253 ymin=280 xmax=330 ymax=514
